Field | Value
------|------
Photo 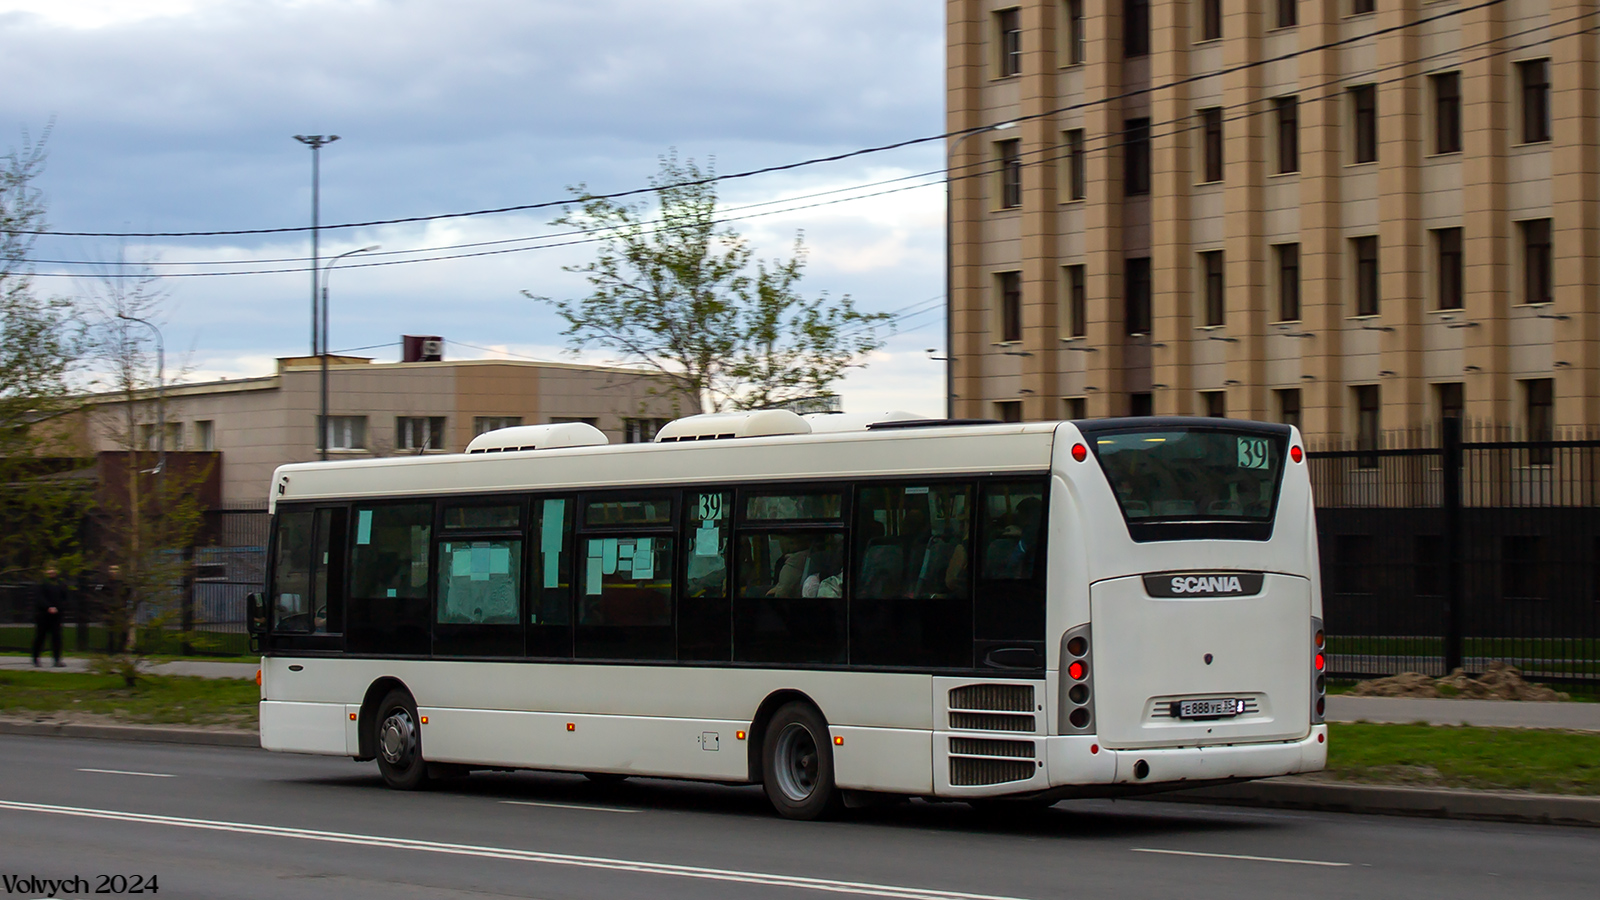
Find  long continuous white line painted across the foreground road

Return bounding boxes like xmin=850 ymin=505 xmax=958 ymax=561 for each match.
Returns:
xmin=0 ymin=801 xmax=1022 ymax=900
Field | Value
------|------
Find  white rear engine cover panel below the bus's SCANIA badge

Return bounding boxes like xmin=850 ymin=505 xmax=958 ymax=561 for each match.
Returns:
xmin=1090 ymin=575 xmax=1312 ymax=749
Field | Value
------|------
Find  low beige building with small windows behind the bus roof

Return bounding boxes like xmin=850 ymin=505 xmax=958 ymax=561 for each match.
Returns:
xmin=82 ymin=357 xmax=680 ymax=506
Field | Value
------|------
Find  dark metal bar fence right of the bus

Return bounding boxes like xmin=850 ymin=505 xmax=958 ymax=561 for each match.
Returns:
xmin=1307 ymin=420 xmax=1600 ymax=685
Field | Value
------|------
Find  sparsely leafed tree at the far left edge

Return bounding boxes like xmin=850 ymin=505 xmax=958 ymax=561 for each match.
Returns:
xmin=0 ymin=128 xmax=91 ymax=573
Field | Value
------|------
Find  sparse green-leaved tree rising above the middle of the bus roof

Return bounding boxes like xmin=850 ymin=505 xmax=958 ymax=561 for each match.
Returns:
xmin=523 ymin=154 xmax=890 ymax=412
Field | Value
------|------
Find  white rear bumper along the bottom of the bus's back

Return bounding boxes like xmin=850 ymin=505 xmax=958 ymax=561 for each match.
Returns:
xmin=1045 ymin=725 xmax=1328 ymax=788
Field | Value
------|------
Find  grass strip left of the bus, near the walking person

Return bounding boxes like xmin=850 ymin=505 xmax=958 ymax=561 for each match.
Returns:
xmin=0 ymin=671 xmax=261 ymax=729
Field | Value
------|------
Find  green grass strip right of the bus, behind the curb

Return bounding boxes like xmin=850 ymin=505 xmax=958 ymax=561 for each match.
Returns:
xmin=1326 ymin=722 xmax=1600 ymax=796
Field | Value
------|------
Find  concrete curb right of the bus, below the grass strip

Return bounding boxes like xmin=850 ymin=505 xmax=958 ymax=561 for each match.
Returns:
xmin=1158 ymin=778 xmax=1600 ymax=826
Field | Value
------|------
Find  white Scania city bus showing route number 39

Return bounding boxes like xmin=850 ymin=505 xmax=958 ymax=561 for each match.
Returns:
xmin=251 ymin=412 xmax=1326 ymax=818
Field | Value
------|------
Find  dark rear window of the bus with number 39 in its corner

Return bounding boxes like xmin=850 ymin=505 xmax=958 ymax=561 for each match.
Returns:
xmin=1086 ymin=428 xmax=1286 ymax=528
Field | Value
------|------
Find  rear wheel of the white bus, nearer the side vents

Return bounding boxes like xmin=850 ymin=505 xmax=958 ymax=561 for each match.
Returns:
xmin=762 ymin=701 xmax=843 ymax=820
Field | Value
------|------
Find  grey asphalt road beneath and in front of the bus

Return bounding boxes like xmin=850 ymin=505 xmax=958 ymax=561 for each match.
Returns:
xmin=0 ymin=737 xmax=1600 ymax=900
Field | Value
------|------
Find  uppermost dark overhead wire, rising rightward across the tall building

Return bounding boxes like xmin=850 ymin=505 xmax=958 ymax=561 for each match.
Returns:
xmin=16 ymin=0 xmax=1506 ymax=237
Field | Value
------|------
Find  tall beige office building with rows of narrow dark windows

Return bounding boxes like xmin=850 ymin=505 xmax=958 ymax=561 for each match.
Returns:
xmin=947 ymin=0 xmax=1600 ymax=440
